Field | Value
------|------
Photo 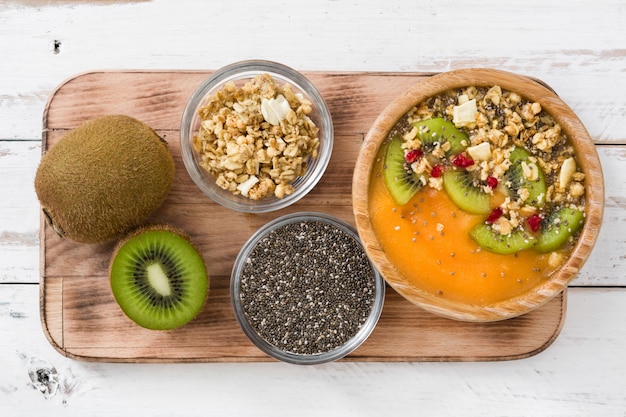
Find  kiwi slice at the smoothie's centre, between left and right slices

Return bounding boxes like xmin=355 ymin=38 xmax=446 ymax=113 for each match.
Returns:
xmin=443 ymin=169 xmax=491 ymax=214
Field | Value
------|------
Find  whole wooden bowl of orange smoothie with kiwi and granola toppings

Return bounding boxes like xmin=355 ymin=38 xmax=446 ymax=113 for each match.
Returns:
xmin=352 ymin=69 xmax=604 ymax=321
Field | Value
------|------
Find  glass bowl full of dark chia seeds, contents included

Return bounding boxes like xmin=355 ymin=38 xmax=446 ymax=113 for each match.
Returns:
xmin=230 ymin=212 xmax=385 ymax=365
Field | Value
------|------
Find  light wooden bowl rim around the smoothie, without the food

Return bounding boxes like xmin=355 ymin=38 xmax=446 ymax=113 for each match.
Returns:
xmin=352 ymin=69 xmax=604 ymax=322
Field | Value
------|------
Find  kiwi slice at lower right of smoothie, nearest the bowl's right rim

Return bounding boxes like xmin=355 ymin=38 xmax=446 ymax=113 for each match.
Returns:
xmin=534 ymin=208 xmax=585 ymax=253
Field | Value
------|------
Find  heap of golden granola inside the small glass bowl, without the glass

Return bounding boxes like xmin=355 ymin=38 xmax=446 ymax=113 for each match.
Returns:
xmin=193 ymin=74 xmax=319 ymax=200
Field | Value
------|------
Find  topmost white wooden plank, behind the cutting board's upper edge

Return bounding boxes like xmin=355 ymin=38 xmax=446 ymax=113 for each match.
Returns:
xmin=0 ymin=0 xmax=626 ymax=142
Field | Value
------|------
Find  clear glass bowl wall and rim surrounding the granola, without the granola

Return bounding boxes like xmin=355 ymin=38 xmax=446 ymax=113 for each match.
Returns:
xmin=180 ymin=60 xmax=334 ymax=213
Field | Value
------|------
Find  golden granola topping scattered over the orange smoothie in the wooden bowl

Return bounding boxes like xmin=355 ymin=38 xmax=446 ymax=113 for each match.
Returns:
xmin=401 ymin=85 xmax=585 ymax=235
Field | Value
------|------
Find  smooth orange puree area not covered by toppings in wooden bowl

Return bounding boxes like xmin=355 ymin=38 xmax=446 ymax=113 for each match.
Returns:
xmin=369 ymin=154 xmax=554 ymax=305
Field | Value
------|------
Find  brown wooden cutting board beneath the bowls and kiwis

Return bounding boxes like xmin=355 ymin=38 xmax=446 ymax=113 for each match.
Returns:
xmin=40 ymin=71 xmax=566 ymax=362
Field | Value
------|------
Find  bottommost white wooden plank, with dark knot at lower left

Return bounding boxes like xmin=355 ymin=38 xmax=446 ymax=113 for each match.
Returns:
xmin=0 ymin=285 xmax=626 ymax=417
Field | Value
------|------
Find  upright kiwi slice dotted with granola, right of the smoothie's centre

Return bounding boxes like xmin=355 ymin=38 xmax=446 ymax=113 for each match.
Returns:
xmin=505 ymin=147 xmax=547 ymax=207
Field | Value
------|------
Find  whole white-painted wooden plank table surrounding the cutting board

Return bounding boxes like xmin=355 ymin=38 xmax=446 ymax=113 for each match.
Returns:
xmin=0 ymin=0 xmax=626 ymax=417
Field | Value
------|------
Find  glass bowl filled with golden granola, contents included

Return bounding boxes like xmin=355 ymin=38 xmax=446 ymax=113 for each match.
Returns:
xmin=180 ymin=60 xmax=334 ymax=213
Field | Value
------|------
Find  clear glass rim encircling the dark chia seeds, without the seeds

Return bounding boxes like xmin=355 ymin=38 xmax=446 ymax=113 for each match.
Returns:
xmin=230 ymin=211 xmax=386 ymax=365
